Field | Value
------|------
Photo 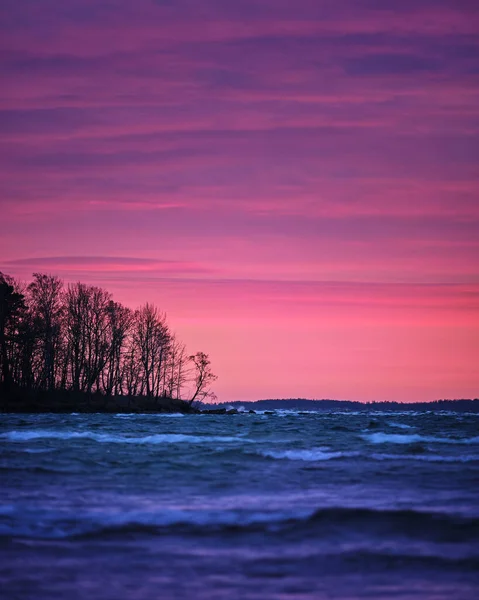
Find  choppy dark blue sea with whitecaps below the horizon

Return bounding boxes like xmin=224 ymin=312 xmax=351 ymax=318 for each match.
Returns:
xmin=0 ymin=411 xmax=479 ymax=600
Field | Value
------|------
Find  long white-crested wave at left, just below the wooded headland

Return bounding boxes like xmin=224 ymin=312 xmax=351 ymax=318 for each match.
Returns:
xmin=0 ymin=430 xmax=251 ymax=444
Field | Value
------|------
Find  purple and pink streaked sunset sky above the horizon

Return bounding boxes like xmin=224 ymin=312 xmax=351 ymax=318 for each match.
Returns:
xmin=0 ymin=0 xmax=479 ymax=402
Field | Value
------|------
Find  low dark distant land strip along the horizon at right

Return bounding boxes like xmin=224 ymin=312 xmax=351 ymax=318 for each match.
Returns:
xmin=217 ymin=398 xmax=479 ymax=413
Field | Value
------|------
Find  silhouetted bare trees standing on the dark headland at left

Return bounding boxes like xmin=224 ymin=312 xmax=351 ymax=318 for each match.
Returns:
xmin=0 ymin=272 xmax=216 ymax=405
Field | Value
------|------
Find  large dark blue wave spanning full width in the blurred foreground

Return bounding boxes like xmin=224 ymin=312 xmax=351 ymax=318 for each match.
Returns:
xmin=0 ymin=507 xmax=479 ymax=550
